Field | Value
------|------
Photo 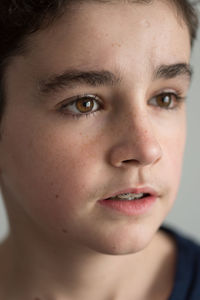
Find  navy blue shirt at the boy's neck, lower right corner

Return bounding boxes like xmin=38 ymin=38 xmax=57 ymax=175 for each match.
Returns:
xmin=160 ymin=226 xmax=200 ymax=300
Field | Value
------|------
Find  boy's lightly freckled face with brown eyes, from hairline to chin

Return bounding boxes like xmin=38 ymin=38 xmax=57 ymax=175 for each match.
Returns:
xmin=0 ymin=1 xmax=190 ymax=254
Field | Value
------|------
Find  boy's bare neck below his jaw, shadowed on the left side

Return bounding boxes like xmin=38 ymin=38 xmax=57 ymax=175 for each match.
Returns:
xmin=0 ymin=224 xmax=173 ymax=300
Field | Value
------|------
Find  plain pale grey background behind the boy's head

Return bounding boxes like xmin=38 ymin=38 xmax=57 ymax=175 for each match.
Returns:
xmin=0 ymin=7 xmax=200 ymax=242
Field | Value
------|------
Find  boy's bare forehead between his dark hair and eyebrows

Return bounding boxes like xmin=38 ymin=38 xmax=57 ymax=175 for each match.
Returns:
xmin=15 ymin=1 xmax=190 ymax=89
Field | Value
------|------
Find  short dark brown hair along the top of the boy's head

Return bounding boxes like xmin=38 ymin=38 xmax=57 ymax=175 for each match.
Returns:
xmin=0 ymin=0 xmax=198 ymax=121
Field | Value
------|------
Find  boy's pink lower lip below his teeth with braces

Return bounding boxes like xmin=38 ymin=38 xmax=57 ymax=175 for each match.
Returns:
xmin=99 ymin=196 xmax=157 ymax=216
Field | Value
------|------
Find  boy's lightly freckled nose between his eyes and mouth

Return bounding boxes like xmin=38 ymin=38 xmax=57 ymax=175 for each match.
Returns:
xmin=110 ymin=109 xmax=162 ymax=167
